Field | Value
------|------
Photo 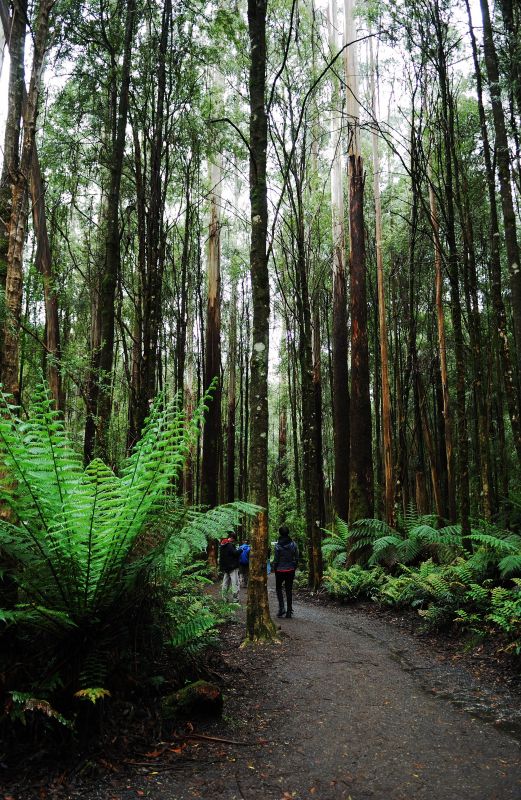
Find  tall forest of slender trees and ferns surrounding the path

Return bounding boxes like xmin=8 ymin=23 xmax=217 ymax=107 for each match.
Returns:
xmin=0 ymin=0 xmax=521 ymax=768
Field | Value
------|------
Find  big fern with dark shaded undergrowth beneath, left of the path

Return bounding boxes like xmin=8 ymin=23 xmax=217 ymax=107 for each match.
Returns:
xmin=0 ymin=386 xmax=256 ymax=737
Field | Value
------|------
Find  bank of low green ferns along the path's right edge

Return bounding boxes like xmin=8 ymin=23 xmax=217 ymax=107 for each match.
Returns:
xmin=323 ymin=514 xmax=521 ymax=656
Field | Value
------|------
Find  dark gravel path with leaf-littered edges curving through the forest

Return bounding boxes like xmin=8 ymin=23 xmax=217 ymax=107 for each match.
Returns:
xmin=0 ymin=586 xmax=521 ymax=800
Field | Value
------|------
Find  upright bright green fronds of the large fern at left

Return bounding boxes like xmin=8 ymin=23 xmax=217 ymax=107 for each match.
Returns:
xmin=0 ymin=386 xmax=207 ymax=628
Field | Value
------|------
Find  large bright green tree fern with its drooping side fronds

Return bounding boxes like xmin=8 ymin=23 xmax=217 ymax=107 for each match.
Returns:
xmin=0 ymin=385 xmax=258 ymax=712
